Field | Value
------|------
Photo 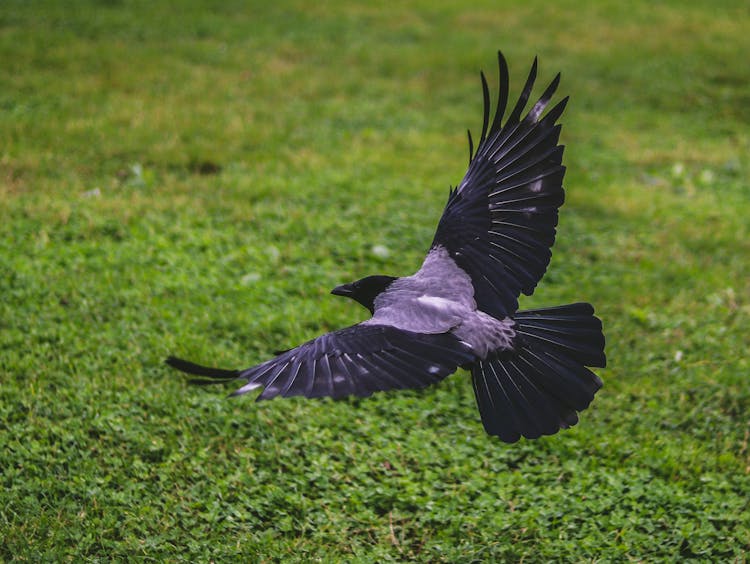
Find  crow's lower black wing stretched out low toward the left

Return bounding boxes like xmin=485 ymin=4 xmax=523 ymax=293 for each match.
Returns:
xmin=167 ymin=324 xmax=475 ymax=400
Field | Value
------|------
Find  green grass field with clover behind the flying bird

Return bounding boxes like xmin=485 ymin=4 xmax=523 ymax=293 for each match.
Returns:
xmin=0 ymin=0 xmax=750 ymax=562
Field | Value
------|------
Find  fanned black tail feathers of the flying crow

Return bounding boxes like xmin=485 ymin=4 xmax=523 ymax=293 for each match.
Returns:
xmin=471 ymin=303 xmax=606 ymax=443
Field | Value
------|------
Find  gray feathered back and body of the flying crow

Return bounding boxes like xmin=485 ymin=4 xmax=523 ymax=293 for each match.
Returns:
xmin=364 ymin=247 xmax=516 ymax=359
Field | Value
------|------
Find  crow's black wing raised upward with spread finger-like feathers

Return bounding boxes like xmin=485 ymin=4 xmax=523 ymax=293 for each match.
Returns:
xmin=432 ymin=53 xmax=568 ymax=318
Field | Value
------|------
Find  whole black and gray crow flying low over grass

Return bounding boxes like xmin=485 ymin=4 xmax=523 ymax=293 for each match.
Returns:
xmin=166 ymin=52 xmax=606 ymax=443
